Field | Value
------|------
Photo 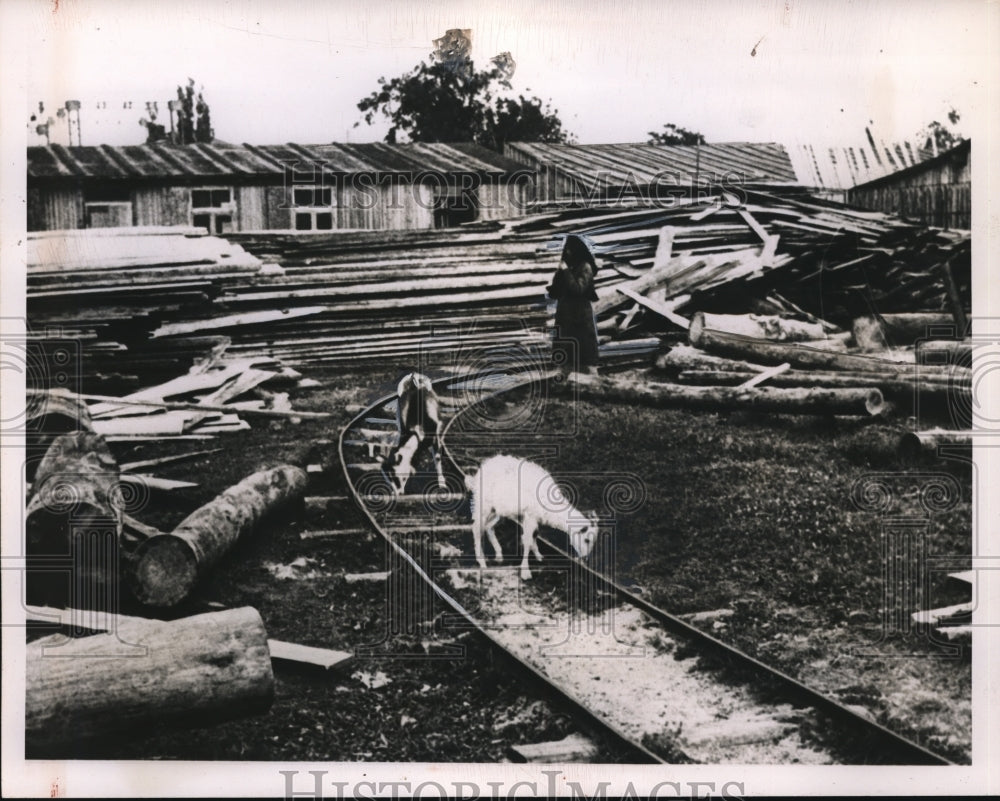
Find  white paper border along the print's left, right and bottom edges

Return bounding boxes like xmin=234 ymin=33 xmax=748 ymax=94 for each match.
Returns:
xmin=0 ymin=0 xmax=1000 ymax=798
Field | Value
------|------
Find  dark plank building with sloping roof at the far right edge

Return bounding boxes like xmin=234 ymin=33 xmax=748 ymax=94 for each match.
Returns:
xmin=848 ymin=139 xmax=972 ymax=229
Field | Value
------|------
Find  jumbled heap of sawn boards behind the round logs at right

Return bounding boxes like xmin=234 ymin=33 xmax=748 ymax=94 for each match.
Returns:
xmin=509 ymin=190 xmax=971 ymax=327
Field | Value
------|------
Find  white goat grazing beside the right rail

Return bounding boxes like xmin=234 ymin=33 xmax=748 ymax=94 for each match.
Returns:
xmin=465 ymin=456 xmax=598 ymax=579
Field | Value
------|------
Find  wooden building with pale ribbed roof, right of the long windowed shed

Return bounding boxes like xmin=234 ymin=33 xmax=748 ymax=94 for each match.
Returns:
xmin=504 ymin=142 xmax=799 ymax=203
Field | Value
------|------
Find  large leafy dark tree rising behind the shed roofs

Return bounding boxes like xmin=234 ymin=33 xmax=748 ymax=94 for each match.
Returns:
xmin=355 ymin=40 xmax=572 ymax=152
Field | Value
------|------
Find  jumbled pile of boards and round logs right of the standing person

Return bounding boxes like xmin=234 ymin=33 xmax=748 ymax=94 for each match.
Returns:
xmin=524 ymin=192 xmax=972 ymax=432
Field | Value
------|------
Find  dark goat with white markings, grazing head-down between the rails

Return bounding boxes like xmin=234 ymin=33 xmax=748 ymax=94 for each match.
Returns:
xmin=382 ymin=373 xmax=445 ymax=494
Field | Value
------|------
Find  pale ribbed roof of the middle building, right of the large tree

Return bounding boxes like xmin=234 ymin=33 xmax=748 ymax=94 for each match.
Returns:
xmin=506 ymin=142 xmax=797 ymax=186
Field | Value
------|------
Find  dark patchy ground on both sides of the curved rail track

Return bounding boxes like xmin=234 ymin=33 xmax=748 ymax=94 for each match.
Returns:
xmin=39 ymin=364 xmax=972 ymax=762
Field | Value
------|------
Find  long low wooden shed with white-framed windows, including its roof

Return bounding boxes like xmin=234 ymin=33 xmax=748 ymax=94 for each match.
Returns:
xmin=27 ymin=143 xmax=533 ymax=234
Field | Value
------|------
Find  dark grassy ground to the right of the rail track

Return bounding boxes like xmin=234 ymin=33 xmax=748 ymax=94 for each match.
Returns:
xmin=453 ymin=382 xmax=972 ymax=761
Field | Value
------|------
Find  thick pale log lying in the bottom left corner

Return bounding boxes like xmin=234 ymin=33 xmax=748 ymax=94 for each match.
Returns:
xmin=25 ymin=607 xmax=274 ymax=758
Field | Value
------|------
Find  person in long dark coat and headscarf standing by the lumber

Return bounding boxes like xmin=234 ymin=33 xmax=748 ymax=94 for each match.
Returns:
xmin=548 ymin=234 xmax=598 ymax=373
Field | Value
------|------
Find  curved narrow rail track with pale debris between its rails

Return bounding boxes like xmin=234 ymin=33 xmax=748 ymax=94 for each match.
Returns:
xmin=339 ymin=363 xmax=951 ymax=765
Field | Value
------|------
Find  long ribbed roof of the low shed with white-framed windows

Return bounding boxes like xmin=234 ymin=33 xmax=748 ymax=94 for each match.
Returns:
xmin=28 ymin=142 xmax=524 ymax=179
